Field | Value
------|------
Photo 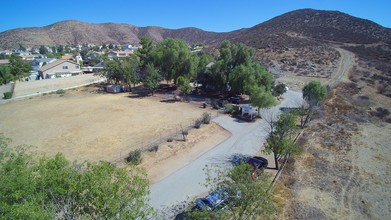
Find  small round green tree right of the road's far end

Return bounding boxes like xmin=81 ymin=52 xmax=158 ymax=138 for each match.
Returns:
xmin=250 ymin=86 xmax=276 ymax=117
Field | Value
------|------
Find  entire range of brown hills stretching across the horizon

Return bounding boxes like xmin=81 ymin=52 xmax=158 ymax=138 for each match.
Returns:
xmin=0 ymin=9 xmax=391 ymax=49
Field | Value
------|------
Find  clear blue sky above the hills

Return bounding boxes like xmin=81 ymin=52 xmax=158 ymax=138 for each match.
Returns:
xmin=0 ymin=0 xmax=391 ymax=32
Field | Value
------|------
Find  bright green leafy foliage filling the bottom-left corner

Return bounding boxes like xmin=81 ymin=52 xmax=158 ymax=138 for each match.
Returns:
xmin=0 ymin=136 xmax=154 ymax=219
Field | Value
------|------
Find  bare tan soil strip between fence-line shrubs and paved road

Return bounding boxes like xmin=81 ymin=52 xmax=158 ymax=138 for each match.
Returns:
xmin=140 ymin=122 xmax=231 ymax=183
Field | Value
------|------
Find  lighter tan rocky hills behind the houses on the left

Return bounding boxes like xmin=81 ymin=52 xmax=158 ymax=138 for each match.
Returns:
xmin=0 ymin=20 xmax=227 ymax=49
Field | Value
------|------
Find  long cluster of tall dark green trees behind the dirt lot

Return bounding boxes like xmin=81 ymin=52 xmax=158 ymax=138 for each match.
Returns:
xmin=96 ymin=37 xmax=280 ymax=102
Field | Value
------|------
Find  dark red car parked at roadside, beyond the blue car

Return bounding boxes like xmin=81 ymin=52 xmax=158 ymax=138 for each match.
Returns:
xmin=231 ymin=154 xmax=268 ymax=178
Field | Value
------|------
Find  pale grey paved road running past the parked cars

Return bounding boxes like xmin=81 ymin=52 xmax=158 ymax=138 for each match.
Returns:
xmin=150 ymin=91 xmax=302 ymax=218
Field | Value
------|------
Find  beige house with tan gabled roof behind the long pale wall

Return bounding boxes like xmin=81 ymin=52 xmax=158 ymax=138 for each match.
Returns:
xmin=38 ymin=60 xmax=82 ymax=79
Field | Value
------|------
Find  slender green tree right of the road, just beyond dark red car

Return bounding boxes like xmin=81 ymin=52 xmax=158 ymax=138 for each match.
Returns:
xmin=264 ymin=112 xmax=299 ymax=170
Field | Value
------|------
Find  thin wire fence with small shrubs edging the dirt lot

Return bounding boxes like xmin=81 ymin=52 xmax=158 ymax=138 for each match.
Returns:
xmin=111 ymin=111 xmax=220 ymax=164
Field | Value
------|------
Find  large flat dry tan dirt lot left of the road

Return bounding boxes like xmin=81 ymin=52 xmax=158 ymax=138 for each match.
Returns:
xmin=0 ymin=87 xmax=226 ymax=161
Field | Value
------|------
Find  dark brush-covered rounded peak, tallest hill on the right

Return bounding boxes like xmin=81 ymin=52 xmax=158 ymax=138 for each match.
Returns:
xmin=230 ymin=9 xmax=391 ymax=48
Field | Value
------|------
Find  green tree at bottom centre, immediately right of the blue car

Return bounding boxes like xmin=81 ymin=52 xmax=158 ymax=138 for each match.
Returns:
xmin=189 ymin=163 xmax=276 ymax=220
